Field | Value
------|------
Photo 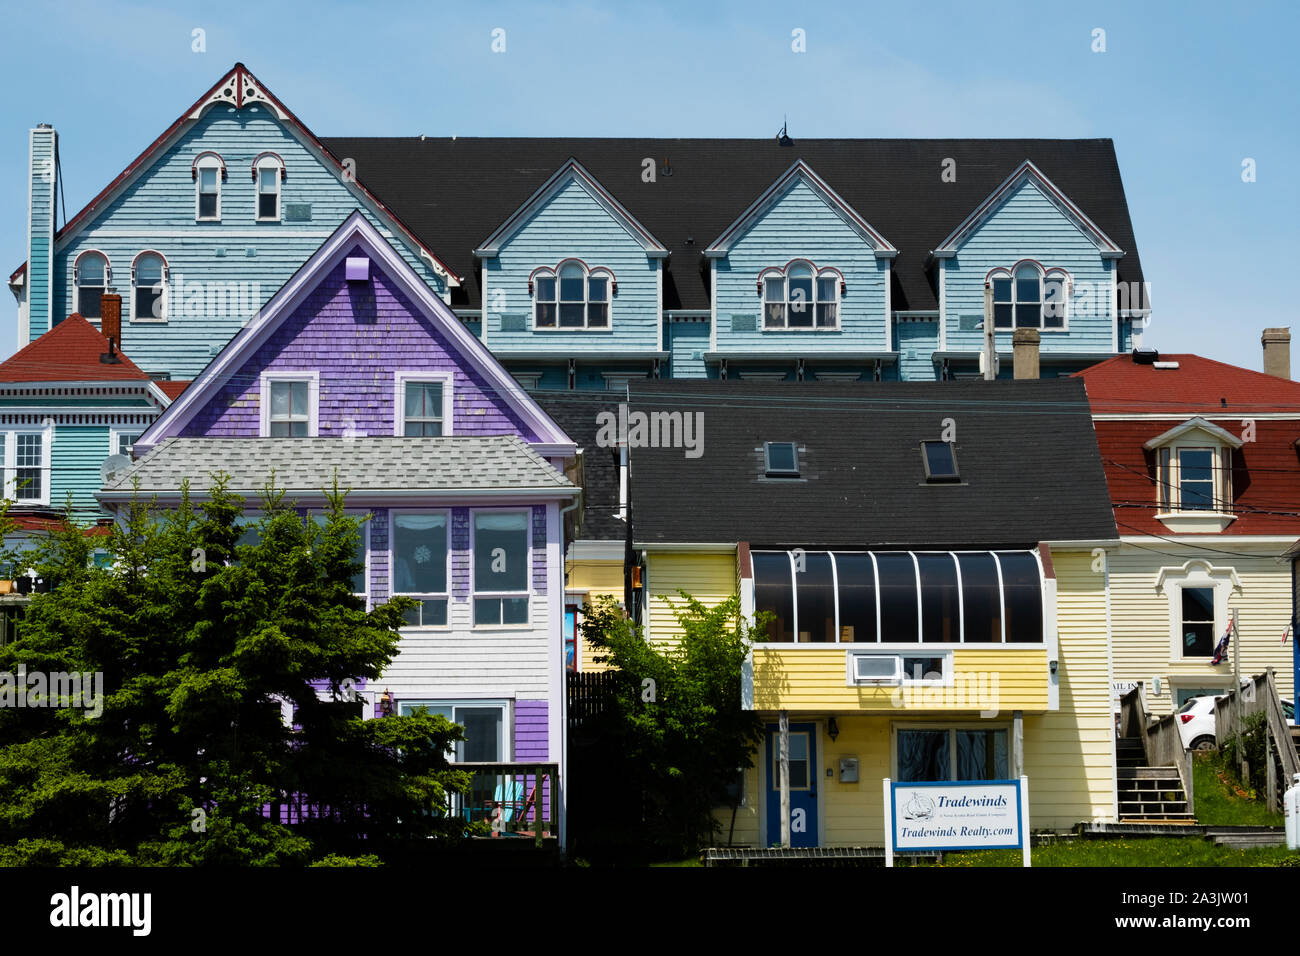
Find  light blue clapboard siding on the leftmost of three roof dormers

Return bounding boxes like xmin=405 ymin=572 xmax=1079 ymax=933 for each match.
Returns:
xmin=484 ymin=179 xmax=659 ymax=355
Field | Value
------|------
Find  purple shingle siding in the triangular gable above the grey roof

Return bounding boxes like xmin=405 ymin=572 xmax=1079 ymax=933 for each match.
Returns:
xmin=182 ymin=250 xmax=537 ymax=441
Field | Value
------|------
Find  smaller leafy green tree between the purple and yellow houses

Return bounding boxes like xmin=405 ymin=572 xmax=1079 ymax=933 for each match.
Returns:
xmin=582 ymin=592 xmax=766 ymax=856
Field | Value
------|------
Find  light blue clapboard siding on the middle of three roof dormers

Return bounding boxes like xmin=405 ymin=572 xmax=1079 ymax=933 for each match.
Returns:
xmin=715 ymin=179 xmax=889 ymax=364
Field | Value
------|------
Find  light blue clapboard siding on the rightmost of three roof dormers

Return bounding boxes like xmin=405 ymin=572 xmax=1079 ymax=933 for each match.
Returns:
xmin=944 ymin=181 xmax=1114 ymax=352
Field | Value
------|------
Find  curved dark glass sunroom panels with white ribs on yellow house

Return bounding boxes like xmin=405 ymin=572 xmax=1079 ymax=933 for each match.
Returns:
xmin=751 ymin=551 xmax=1044 ymax=644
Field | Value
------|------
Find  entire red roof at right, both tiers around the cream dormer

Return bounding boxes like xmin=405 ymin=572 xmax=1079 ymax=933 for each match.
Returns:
xmin=1075 ymin=355 xmax=1300 ymax=537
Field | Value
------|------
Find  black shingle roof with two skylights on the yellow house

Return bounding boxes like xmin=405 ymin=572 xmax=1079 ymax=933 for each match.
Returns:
xmin=631 ymin=378 xmax=1115 ymax=549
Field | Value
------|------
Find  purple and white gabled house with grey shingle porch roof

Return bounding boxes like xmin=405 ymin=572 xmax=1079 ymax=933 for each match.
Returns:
xmin=99 ymin=212 xmax=579 ymax=845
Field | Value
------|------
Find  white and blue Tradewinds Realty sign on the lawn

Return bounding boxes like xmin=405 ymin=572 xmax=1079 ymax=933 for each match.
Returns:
xmin=884 ymin=777 xmax=1030 ymax=866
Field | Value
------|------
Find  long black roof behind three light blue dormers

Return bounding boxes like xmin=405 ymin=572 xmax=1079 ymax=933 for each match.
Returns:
xmin=321 ymin=137 xmax=1141 ymax=311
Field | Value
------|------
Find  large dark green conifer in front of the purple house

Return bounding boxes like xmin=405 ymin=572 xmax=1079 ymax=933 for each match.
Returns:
xmin=0 ymin=479 xmax=468 ymax=865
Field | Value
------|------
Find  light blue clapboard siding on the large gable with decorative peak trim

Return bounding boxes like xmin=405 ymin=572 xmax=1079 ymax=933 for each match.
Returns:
xmin=47 ymin=105 xmax=445 ymax=378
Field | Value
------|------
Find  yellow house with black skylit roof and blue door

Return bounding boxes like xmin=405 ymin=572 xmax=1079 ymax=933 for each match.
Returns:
xmin=631 ymin=380 xmax=1118 ymax=847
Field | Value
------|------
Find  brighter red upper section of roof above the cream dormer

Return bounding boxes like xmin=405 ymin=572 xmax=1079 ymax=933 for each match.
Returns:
xmin=1075 ymin=355 xmax=1300 ymax=415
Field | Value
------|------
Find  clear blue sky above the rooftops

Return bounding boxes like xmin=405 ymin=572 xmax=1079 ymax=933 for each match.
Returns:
xmin=0 ymin=0 xmax=1300 ymax=375
